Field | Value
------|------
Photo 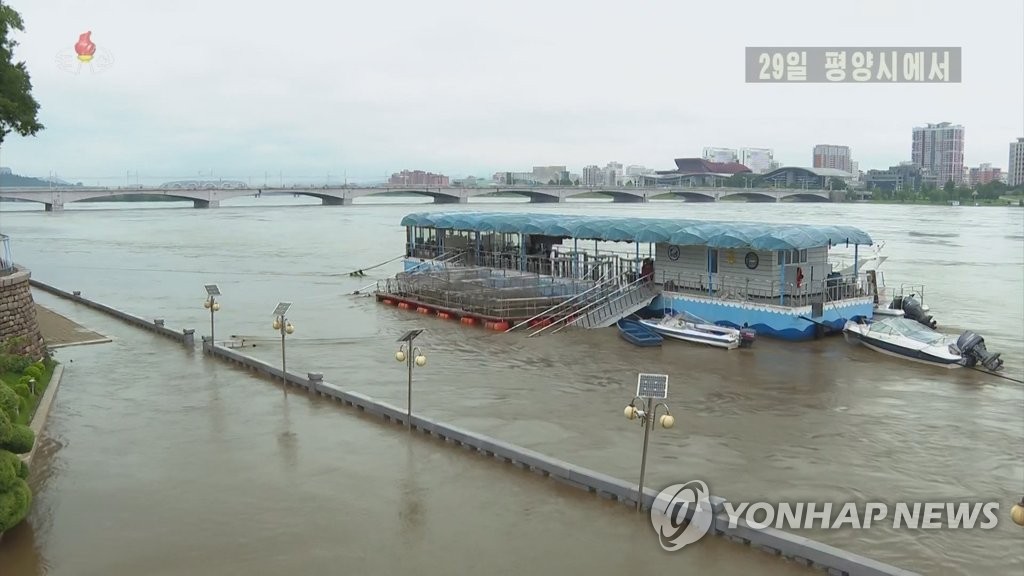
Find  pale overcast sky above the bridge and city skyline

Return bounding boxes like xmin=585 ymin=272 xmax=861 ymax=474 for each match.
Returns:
xmin=0 ymin=0 xmax=1024 ymax=183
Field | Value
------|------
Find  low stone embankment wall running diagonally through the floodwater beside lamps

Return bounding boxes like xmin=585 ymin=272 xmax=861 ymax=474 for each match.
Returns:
xmin=33 ymin=281 xmax=913 ymax=576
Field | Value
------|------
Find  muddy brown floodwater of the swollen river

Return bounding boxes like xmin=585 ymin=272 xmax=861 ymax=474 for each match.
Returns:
xmin=0 ymin=197 xmax=1024 ymax=576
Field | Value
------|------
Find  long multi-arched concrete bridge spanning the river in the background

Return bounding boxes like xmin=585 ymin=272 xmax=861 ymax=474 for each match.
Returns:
xmin=0 ymin=186 xmax=843 ymax=211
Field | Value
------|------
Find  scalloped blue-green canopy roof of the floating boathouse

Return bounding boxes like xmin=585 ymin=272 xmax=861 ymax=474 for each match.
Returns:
xmin=401 ymin=212 xmax=872 ymax=250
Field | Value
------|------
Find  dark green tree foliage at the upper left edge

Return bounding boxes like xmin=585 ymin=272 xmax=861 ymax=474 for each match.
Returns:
xmin=0 ymin=3 xmax=43 ymax=145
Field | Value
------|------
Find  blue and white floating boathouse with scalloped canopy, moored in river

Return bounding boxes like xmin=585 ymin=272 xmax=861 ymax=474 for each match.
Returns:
xmin=376 ymin=212 xmax=879 ymax=340
